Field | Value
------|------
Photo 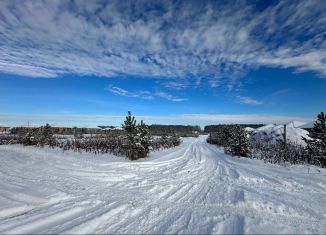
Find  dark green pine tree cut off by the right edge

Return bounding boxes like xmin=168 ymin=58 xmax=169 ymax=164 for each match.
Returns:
xmin=303 ymin=112 xmax=326 ymax=167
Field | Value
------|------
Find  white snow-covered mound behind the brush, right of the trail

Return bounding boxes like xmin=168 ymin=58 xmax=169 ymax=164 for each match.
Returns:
xmin=251 ymin=121 xmax=309 ymax=146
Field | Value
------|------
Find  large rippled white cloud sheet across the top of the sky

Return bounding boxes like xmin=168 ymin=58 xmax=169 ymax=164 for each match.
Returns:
xmin=0 ymin=0 xmax=326 ymax=89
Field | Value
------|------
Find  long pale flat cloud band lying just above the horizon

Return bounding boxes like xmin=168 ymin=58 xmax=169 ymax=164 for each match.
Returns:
xmin=0 ymin=113 xmax=313 ymax=126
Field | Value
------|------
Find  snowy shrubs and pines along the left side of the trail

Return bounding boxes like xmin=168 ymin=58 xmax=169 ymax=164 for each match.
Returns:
xmin=0 ymin=112 xmax=181 ymax=160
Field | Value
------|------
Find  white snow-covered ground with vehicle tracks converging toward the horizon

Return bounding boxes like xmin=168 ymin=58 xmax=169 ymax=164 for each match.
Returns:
xmin=0 ymin=136 xmax=326 ymax=234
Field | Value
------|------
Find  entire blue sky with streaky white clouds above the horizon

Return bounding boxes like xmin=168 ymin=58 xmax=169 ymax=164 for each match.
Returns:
xmin=0 ymin=0 xmax=326 ymax=125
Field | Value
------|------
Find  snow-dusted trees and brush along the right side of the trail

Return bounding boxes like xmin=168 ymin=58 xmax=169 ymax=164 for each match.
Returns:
xmin=207 ymin=112 xmax=326 ymax=167
